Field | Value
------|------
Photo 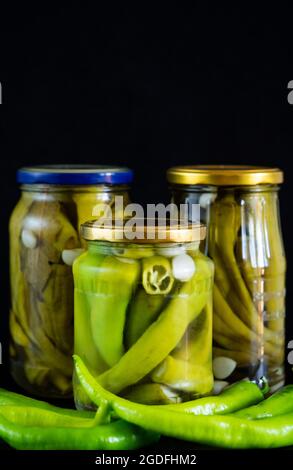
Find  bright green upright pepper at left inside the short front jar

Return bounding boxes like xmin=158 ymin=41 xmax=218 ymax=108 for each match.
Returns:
xmin=73 ymin=254 xmax=140 ymax=366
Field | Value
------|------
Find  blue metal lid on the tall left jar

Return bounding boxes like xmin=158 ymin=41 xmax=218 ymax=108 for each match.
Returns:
xmin=17 ymin=165 xmax=133 ymax=185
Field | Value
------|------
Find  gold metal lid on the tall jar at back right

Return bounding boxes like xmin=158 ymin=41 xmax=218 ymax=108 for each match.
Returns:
xmin=167 ymin=165 xmax=284 ymax=186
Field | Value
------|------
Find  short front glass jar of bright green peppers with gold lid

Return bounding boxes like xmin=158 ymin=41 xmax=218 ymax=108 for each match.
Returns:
xmin=73 ymin=222 xmax=213 ymax=409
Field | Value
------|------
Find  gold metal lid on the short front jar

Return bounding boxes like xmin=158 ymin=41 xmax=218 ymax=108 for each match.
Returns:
xmin=81 ymin=219 xmax=206 ymax=244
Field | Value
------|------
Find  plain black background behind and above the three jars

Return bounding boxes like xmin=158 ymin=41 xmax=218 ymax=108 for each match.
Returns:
xmin=0 ymin=2 xmax=293 ymax=458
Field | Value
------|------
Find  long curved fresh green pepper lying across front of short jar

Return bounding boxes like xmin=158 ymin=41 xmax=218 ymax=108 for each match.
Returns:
xmin=74 ymin=356 xmax=293 ymax=449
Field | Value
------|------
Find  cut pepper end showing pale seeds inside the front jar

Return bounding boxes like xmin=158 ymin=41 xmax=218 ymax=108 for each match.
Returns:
xmin=142 ymin=256 xmax=174 ymax=295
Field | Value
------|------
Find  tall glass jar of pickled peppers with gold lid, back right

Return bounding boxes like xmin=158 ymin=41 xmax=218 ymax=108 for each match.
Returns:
xmin=167 ymin=166 xmax=286 ymax=391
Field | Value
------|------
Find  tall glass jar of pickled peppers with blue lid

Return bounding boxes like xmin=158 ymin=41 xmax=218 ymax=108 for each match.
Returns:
xmin=10 ymin=166 xmax=133 ymax=397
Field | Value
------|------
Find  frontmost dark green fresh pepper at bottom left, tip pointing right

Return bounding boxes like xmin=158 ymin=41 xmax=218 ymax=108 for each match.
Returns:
xmin=0 ymin=415 xmax=159 ymax=450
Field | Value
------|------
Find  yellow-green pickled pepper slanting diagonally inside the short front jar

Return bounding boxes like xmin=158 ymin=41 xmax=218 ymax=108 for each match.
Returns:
xmin=98 ymin=256 xmax=212 ymax=393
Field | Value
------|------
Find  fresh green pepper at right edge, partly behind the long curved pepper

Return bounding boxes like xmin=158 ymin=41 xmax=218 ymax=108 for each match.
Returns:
xmin=233 ymin=385 xmax=293 ymax=419
